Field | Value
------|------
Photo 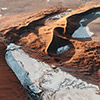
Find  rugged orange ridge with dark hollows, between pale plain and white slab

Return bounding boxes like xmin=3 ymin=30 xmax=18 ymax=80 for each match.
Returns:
xmin=0 ymin=5 xmax=100 ymax=94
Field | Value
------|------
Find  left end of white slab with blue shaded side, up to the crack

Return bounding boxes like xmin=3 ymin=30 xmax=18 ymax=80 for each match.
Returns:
xmin=5 ymin=43 xmax=52 ymax=93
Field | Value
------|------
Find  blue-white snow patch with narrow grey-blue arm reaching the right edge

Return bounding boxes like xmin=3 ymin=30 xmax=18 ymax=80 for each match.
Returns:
xmin=72 ymin=12 xmax=100 ymax=38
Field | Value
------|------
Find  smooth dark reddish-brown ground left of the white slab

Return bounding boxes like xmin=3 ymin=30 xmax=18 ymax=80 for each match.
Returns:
xmin=0 ymin=40 xmax=29 ymax=100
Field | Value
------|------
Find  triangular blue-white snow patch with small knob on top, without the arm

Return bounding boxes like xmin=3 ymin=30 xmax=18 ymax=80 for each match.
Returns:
xmin=72 ymin=18 xmax=94 ymax=38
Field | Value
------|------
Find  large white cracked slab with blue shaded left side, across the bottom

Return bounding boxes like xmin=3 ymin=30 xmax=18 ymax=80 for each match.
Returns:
xmin=5 ymin=43 xmax=100 ymax=100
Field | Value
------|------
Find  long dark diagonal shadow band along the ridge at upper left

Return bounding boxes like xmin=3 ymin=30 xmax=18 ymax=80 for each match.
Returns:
xmin=2 ymin=9 xmax=63 ymax=42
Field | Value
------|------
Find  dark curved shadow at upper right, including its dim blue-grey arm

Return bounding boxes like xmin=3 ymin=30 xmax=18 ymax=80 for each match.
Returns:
xmin=65 ymin=7 xmax=100 ymax=38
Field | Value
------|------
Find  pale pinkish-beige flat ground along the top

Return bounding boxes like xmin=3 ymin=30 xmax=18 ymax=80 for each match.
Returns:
xmin=0 ymin=0 xmax=99 ymax=15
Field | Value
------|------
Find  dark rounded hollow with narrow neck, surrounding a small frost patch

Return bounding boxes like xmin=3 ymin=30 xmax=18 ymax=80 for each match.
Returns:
xmin=47 ymin=27 xmax=75 ymax=62
